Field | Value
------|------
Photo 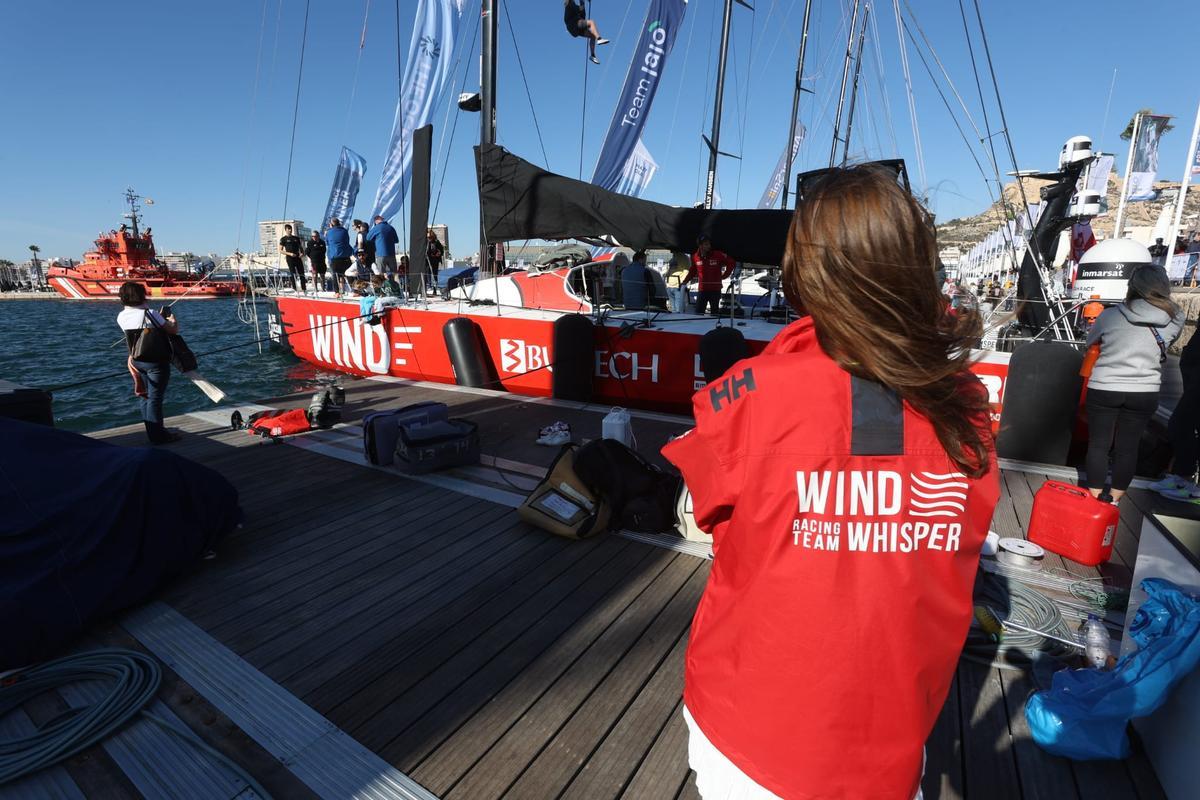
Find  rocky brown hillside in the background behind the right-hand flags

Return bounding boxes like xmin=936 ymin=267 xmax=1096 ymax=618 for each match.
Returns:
xmin=937 ymin=174 xmax=1200 ymax=253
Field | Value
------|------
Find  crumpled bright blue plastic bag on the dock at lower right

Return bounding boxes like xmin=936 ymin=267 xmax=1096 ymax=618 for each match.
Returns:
xmin=1025 ymin=578 xmax=1200 ymax=759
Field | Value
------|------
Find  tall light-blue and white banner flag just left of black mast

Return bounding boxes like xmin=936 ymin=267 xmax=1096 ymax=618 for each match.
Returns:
xmin=372 ymin=0 xmax=466 ymax=221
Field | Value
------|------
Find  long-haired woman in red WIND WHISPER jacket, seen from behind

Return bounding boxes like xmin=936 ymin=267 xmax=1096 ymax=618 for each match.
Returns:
xmin=664 ymin=167 xmax=1000 ymax=800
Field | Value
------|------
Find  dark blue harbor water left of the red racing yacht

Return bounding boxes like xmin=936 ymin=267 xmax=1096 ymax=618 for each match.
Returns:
xmin=0 ymin=299 xmax=328 ymax=431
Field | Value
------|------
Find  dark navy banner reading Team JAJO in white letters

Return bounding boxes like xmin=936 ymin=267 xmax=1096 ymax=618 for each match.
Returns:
xmin=592 ymin=0 xmax=688 ymax=192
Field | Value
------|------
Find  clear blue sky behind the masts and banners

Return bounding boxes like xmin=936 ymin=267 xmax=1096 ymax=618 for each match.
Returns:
xmin=0 ymin=0 xmax=1200 ymax=260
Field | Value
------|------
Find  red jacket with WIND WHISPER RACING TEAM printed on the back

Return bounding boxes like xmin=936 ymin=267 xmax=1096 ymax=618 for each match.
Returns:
xmin=662 ymin=318 xmax=1000 ymax=800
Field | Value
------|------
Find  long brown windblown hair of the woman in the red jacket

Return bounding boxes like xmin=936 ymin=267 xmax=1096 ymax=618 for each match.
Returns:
xmin=782 ymin=166 xmax=990 ymax=477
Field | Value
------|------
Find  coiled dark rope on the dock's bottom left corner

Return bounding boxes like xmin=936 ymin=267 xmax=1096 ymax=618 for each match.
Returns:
xmin=0 ymin=648 xmax=270 ymax=798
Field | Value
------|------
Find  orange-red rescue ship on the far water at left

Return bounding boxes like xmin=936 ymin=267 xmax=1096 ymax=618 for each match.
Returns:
xmin=47 ymin=188 xmax=244 ymax=300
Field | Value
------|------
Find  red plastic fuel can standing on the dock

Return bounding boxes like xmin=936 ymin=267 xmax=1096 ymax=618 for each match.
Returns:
xmin=1027 ymin=481 xmax=1121 ymax=566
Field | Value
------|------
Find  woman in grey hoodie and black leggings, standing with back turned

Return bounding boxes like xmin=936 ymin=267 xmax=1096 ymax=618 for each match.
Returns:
xmin=1086 ymin=264 xmax=1184 ymax=504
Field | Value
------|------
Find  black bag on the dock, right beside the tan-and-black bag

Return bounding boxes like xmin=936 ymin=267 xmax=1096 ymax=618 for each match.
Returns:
xmin=575 ymin=439 xmax=680 ymax=534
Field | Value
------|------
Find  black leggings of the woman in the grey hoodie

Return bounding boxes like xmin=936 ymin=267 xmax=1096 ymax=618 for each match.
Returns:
xmin=1087 ymin=389 xmax=1158 ymax=492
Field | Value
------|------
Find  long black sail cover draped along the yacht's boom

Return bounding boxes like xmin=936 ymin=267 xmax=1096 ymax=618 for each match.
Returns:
xmin=475 ymin=145 xmax=792 ymax=265
